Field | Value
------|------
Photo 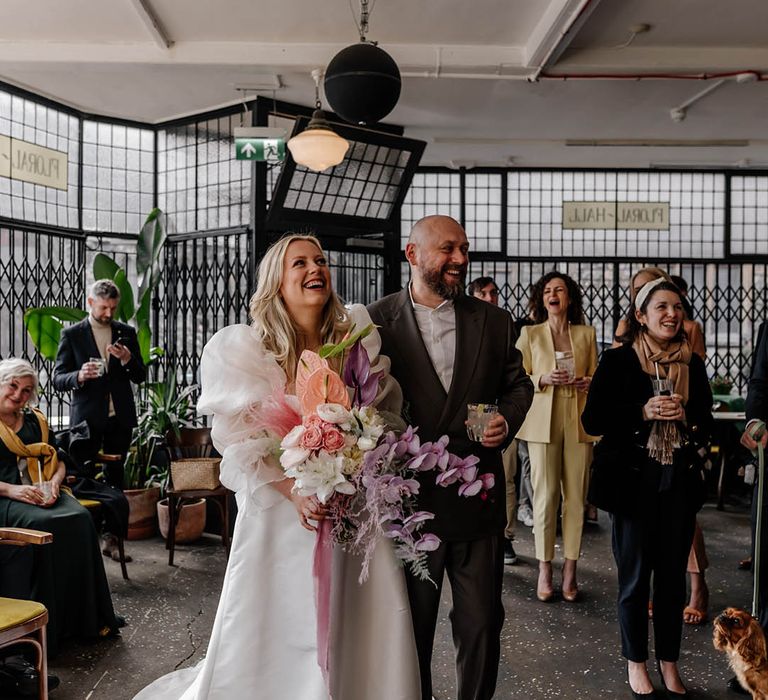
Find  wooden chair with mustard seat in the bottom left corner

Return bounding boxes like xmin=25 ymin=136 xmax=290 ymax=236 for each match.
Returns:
xmin=0 ymin=527 xmax=53 ymax=700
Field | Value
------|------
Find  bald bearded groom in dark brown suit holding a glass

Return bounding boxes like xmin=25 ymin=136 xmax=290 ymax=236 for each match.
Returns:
xmin=368 ymin=216 xmax=533 ymax=700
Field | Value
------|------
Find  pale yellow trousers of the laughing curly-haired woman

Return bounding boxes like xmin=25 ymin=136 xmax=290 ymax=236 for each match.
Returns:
xmin=528 ymin=387 xmax=592 ymax=561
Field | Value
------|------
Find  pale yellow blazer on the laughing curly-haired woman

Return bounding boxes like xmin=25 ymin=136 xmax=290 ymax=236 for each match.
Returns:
xmin=517 ymin=321 xmax=597 ymax=442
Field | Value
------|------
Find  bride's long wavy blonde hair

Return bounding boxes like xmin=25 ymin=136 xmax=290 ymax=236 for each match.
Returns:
xmin=249 ymin=233 xmax=350 ymax=379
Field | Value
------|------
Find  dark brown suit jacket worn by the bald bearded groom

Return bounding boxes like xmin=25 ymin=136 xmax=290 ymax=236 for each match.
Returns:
xmin=368 ymin=289 xmax=533 ymax=541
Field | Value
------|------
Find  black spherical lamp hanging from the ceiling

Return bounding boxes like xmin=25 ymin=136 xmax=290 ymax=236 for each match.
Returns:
xmin=323 ymin=41 xmax=400 ymax=124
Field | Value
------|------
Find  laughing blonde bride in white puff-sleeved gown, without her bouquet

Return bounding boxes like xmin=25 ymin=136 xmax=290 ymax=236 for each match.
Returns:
xmin=135 ymin=235 xmax=420 ymax=700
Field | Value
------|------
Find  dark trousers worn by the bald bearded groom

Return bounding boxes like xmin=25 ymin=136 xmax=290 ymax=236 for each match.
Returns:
xmin=406 ymin=532 xmax=504 ymax=700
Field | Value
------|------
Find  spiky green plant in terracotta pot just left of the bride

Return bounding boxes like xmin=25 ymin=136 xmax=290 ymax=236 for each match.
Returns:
xmin=125 ymin=373 xmax=197 ymax=540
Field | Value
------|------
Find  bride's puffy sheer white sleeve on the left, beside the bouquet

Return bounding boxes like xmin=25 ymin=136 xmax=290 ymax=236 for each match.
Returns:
xmin=197 ymin=324 xmax=292 ymax=510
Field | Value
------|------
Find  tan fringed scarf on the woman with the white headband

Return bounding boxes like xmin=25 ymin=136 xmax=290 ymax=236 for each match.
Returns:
xmin=632 ymin=332 xmax=691 ymax=464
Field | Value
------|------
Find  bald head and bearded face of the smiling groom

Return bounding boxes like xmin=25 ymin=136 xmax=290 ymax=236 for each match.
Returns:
xmin=405 ymin=215 xmax=469 ymax=308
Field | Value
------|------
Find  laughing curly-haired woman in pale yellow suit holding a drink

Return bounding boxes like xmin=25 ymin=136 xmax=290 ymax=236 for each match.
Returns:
xmin=517 ymin=271 xmax=597 ymax=602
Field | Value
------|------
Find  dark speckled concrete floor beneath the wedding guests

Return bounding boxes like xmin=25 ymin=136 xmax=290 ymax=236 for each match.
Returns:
xmin=39 ymin=503 xmax=751 ymax=700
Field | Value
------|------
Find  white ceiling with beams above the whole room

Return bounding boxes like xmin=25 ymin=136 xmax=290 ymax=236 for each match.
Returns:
xmin=0 ymin=0 xmax=768 ymax=167
